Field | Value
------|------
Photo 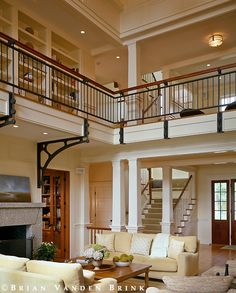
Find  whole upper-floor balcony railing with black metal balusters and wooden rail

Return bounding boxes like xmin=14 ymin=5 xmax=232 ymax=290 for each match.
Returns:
xmin=0 ymin=33 xmax=236 ymax=125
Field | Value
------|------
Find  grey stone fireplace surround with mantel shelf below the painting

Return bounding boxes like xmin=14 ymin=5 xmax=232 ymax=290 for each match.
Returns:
xmin=0 ymin=202 xmax=45 ymax=253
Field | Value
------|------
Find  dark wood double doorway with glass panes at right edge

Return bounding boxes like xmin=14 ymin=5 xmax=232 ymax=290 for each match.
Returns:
xmin=212 ymin=179 xmax=236 ymax=245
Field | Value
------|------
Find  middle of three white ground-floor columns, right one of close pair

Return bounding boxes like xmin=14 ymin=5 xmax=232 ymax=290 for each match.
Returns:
xmin=126 ymin=159 xmax=142 ymax=233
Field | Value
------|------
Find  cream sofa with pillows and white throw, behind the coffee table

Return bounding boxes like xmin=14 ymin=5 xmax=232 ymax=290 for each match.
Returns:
xmin=96 ymin=232 xmax=198 ymax=279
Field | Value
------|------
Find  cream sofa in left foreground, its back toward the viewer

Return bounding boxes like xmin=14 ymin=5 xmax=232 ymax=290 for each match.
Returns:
xmin=0 ymin=254 xmax=117 ymax=293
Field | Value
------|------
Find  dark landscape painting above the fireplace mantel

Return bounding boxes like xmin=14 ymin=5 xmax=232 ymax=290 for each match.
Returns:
xmin=0 ymin=175 xmax=31 ymax=202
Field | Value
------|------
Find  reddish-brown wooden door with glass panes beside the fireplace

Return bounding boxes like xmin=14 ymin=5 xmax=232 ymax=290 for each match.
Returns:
xmin=42 ymin=170 xmax=69 ymax=261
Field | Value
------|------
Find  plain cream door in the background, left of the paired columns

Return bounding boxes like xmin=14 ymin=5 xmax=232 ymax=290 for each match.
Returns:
xmin=90 ymin=182 xmax=112 ymax=228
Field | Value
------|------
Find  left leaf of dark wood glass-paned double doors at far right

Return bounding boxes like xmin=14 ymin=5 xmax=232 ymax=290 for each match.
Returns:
xmin=212 ymin=180 xmax=230 ymax=244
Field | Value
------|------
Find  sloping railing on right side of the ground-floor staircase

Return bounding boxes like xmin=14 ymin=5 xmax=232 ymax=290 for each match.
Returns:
xmin=173 ymin=175 xmax=192 ymax=231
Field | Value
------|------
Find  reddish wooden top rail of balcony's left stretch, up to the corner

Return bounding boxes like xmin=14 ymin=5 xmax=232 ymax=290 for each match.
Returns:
xmin=0 ymin=32 xmax=114 ymax=95
